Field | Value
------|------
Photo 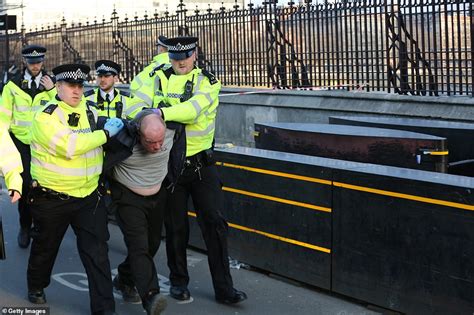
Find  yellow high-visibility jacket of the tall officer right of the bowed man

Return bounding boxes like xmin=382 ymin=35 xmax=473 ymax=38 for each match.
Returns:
xmin=153 ymin=68 xmax=221 ymax=156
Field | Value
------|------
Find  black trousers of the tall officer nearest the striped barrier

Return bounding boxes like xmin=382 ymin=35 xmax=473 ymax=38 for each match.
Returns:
xmin=165 ymin=164 xmax=233 ymax=296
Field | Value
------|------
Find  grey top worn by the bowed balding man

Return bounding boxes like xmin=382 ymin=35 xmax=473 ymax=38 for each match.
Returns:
xmin=112 ymin=129 xmax=174 ymax=189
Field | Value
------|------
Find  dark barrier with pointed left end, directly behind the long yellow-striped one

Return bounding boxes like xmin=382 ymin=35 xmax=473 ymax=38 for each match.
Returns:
xmin=255 ymin=122 xmax=448 ymax=173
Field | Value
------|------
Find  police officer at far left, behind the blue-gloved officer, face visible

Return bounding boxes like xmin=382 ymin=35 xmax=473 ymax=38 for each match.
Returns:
xmin=0 ymin=45 xmax=56 ymax=248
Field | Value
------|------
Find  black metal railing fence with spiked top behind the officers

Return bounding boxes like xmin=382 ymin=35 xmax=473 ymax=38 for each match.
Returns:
xmin=0 ymin=0 xmax=474 ymax=96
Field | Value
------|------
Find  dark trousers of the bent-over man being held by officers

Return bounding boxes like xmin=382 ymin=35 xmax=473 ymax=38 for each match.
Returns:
xmin=110 ymin=180 xmax=166 ymax=301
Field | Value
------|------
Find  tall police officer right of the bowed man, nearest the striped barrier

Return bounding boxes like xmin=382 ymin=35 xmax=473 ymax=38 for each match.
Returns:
xmin=154 ymin=37 xmax=247 ymax=304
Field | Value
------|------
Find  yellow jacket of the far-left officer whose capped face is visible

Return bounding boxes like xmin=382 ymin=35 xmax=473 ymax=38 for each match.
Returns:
xmin=0 ymin=72 xmax=56 ymax=144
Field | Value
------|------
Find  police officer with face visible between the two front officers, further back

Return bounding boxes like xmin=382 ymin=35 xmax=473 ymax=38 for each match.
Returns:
xmin=84 ymin=60 xmax=134 ymax=118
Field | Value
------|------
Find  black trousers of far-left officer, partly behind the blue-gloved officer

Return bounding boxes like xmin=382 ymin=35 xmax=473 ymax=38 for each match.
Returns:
xmin=10 ymin=133 xmax=32 ymax=229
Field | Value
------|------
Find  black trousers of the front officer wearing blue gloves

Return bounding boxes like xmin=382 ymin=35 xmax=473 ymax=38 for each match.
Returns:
xmin=27 ymin=189 xmax=115 ymax=314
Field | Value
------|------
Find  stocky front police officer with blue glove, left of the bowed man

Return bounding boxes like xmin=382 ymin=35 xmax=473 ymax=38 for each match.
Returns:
xmin=27 ymin=64 xmax=123 ymax=314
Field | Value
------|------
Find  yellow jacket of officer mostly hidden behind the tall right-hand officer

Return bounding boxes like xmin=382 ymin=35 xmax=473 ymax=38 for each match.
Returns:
xmin=130 ymin=52 xmax=170 ymax=109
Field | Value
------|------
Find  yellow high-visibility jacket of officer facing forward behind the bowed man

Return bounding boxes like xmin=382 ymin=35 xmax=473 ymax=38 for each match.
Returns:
xmin=84 ymin=88 xmax=145 ymax=118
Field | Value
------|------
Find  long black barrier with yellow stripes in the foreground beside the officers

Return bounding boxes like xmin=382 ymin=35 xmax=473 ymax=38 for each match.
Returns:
xmin=190 ymin=147 xmax=474 ymax=314
